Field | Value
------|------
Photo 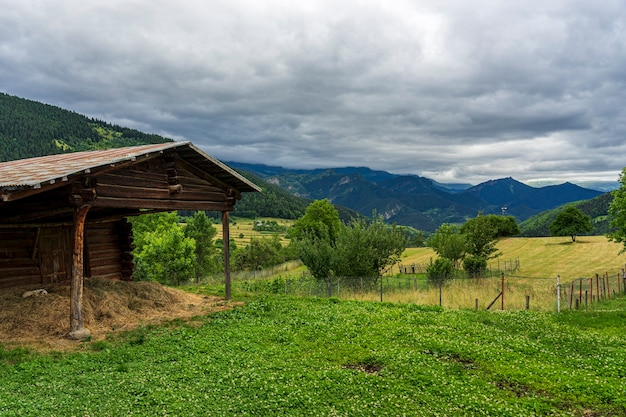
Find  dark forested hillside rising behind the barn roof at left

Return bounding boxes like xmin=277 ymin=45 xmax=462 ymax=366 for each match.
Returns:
xmin=0 ymin=93 xmax=170 ymax=162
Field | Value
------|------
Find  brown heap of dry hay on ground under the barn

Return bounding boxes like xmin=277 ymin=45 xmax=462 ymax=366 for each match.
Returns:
xmin=0 ymin=279 xmax=233 ymax=350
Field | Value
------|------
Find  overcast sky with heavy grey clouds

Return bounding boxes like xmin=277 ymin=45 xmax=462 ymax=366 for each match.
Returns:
xmin=0 ymin=0 xmax=626 ymax=184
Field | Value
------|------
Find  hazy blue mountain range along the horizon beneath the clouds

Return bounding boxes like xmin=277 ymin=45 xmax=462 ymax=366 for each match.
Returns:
xmin=227 ymin=161 xmax=603 ymax=232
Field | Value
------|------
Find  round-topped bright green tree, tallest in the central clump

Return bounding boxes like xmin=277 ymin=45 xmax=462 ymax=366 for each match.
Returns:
xmin=289 ymin=199 xmax=341 ymax=240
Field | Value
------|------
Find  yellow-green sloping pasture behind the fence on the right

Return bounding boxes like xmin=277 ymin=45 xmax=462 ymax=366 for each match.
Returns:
xmin=238 ymin=236 xmax=626 ymax=311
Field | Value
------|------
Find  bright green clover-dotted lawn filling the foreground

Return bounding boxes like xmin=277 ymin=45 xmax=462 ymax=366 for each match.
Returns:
xmin=0 ymin=297 xmax=626 ymax=417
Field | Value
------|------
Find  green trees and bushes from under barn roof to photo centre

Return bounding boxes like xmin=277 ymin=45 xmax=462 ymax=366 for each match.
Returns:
xmin=130 ymin=200 xmax=408 ymax=285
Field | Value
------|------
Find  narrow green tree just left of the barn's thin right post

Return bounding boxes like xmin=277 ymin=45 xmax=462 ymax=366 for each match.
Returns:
xmin=185 ymin=211 xmax=222 ymax=283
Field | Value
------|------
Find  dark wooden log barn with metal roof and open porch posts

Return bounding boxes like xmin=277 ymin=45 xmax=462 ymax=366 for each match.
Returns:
xmin=0 ymin=142 xmax=260 ymax=331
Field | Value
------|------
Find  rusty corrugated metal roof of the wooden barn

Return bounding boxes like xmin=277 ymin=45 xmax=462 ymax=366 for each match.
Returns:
xmin=0 ymin=142 xmax=260 ymax=192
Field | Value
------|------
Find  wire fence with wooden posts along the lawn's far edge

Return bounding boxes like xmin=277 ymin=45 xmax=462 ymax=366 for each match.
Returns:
xmin=228 ymin=261 xmax=626 ymax=311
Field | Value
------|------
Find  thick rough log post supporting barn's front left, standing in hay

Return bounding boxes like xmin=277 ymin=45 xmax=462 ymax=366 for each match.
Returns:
xmin=68 ymin=204 xmax=90 ymax=339
